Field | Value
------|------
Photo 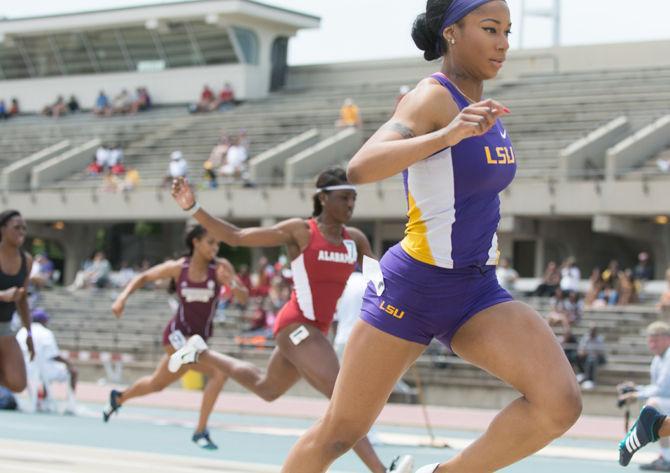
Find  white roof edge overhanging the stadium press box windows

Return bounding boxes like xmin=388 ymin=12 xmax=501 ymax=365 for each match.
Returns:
xmin=0 ymin=0 xmax=321 ymax=36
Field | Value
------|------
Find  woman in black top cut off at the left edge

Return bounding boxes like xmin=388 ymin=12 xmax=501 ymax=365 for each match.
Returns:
xmin=0 ymin=210 xmax=35 ymax=393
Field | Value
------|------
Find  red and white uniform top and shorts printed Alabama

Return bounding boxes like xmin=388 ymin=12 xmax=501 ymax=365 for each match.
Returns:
xmin=274 ymin=219 xmax=358 ymax=335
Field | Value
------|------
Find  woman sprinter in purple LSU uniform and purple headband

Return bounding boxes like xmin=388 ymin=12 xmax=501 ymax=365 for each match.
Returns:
xmin=282 ymin=0 xmax=581 ymax=473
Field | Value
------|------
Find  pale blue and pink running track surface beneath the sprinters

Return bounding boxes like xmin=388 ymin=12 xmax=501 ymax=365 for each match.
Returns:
xmin=0 ymin=383 xmax=658 ymax=473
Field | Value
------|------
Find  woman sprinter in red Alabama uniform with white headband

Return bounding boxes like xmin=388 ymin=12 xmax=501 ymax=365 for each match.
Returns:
xmin=170 ymin=169 xmax=412 ymax=472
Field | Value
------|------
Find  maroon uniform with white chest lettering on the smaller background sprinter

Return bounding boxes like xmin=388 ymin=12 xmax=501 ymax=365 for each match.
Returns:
xmin=163 ymin=258 xmax=221 ymax=348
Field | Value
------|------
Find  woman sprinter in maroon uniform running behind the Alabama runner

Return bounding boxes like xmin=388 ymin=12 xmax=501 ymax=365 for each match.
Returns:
xmin=103 ymin=225 xmax=248 ymax=450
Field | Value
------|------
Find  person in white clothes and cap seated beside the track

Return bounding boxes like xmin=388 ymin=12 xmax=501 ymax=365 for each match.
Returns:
xmin=16 ymin=308 xmax=77 ymax=414
